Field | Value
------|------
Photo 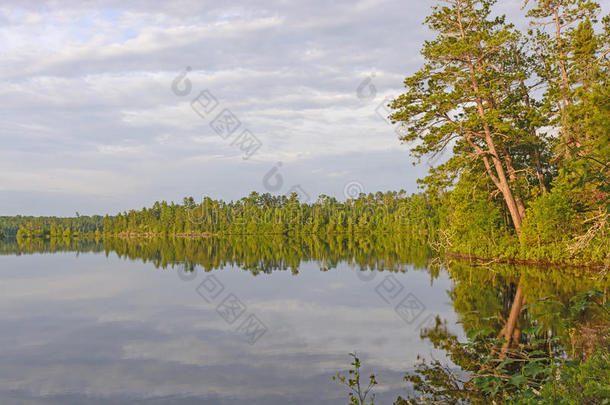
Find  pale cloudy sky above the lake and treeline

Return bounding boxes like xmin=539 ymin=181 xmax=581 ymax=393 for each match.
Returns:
xmin=0 ymin=0 xmax=588 ymax=216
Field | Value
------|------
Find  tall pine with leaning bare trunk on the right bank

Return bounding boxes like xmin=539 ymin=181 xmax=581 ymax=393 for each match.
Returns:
xmin=390 ymin=0 xmax=546 ymax=234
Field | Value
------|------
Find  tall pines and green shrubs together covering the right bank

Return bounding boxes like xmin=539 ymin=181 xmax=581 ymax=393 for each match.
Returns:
xmin=390 ymin=0 xmax=610 ymax=265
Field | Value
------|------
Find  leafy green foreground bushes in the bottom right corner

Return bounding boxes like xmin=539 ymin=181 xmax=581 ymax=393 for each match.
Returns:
xmin=346 ymin=280 xmax=610 ymax=405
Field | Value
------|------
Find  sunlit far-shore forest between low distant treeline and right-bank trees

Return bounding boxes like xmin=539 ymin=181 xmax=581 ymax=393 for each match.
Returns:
xmin=97 ymin=192 xmax=438 ymax=241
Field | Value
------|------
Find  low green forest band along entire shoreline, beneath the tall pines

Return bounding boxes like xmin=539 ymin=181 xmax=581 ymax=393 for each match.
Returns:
xmin=3 ymin=184 xmax=610 ymax=265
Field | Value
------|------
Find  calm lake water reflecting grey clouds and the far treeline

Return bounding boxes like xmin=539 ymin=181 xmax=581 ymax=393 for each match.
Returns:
xmin=0 ymin=237 xmax=604 ymax=405
